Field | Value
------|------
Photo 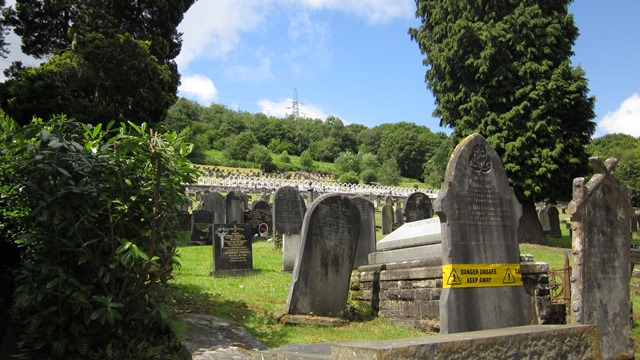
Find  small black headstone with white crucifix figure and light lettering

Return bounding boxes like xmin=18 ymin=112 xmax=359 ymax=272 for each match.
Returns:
xmin=213 ymin=224 xmax=253 ymax=275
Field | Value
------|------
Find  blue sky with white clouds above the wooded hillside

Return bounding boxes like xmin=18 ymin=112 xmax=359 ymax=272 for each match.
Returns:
xmin=0 ymin=0 xmax=640 ymax=136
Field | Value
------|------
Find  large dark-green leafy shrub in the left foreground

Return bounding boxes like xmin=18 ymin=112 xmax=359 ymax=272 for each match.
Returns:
xmin=0 ymin=117 xmax=196 ymax=359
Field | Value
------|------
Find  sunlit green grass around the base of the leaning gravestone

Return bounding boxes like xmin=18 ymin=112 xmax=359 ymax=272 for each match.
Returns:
xmin=170 ymin=240 xmax=428 ymax=348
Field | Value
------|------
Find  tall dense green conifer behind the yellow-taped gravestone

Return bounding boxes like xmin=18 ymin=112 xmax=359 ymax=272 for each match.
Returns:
xmin=409 ymin=0 xmax=595 ymax=243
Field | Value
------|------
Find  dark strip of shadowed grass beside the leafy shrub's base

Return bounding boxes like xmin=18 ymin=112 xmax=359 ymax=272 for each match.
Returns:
xmin=170 ymin=284 xmax=288 ymax=348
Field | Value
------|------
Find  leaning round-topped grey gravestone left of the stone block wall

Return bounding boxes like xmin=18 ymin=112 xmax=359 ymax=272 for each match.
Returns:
xmin=285 ymin=194 xmax=360 ymax=316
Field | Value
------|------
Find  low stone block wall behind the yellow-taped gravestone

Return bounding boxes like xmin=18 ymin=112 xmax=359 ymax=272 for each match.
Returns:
xmin=351 ymin=255 xmax=558 ymax=331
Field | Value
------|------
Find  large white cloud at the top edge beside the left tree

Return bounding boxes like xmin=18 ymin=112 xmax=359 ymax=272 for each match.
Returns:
xmin=176 ymin=0 xmax=270 ymax=72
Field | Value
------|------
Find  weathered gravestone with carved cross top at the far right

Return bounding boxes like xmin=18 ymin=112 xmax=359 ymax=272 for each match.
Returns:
xmin=568 ymin=157 xmax=633 ymax=359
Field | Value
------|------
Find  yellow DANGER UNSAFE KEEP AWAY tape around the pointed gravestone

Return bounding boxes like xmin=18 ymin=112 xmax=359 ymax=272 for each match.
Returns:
xmin=442 ymin=264 xmax=522 ymax=288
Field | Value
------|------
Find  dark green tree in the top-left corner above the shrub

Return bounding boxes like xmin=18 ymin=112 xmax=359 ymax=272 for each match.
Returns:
xmin=2 ymin=0 xmax=194 ymax=124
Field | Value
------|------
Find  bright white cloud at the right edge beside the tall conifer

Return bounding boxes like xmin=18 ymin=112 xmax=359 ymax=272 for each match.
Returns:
xmin=598 ymin=94 xmax=640 ymax=137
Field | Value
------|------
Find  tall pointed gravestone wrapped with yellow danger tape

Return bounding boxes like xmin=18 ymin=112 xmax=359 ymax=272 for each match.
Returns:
xmin=434 ymin=134 xmax=531 ymax=334
